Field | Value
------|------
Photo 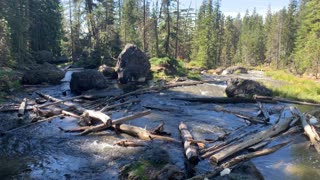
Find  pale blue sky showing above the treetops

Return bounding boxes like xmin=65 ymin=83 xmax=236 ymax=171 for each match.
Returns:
xmin=172 ymin=0 xmax=290 ymax=16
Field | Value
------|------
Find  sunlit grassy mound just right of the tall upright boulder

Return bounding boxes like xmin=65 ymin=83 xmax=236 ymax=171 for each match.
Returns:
xmin=150 ymin=57 xmax=201 ymax=80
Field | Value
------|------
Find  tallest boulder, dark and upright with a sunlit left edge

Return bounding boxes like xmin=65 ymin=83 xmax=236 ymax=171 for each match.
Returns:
xmin=116 ymin=44 xmax=151 ymax=83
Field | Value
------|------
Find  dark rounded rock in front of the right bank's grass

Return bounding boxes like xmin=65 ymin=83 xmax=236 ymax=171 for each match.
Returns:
xmin=225 ymin=78 xmax=272 ymax=97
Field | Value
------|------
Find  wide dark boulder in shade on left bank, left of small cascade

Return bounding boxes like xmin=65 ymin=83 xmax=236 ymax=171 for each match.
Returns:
xmin=22 ymin=63 xmax=64 ymax=85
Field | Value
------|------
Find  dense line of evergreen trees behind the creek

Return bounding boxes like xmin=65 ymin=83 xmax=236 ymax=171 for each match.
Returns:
xmin=0 ymin=0 xmax=320 ymax=74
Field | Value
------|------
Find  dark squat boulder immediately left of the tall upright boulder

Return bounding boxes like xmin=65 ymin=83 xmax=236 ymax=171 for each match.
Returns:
xmin=70 ymin=69 xmax=108 ymax=93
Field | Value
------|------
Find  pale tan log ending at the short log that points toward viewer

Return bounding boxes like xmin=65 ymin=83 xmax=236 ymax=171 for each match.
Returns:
xmin=112 ymin=124 xmax=180 ymax=143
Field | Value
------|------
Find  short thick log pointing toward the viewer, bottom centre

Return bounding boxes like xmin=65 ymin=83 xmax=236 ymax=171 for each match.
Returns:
xmin=179 ymin=122 xmax=199 ymax=164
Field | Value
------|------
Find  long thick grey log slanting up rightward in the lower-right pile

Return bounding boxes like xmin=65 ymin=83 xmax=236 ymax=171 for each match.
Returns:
xmin=210 ymin=107 xmax=298 ymax=163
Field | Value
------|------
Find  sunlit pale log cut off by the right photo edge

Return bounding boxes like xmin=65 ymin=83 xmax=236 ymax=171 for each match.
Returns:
xmin=298 ymin=113 xmax=320 ymax=153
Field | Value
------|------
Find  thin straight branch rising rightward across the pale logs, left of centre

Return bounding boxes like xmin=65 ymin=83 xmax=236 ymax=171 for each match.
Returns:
xmin=80 ymin=110 xmax=151 ymax=136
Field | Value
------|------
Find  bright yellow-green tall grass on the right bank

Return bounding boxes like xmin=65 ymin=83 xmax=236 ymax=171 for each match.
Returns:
xmin=265 ymin=70 xmax=320 ymax=102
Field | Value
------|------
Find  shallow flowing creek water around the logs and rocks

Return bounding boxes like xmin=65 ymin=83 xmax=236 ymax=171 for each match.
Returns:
xmin=0 ymin=72 xmax=320 ymax=179
